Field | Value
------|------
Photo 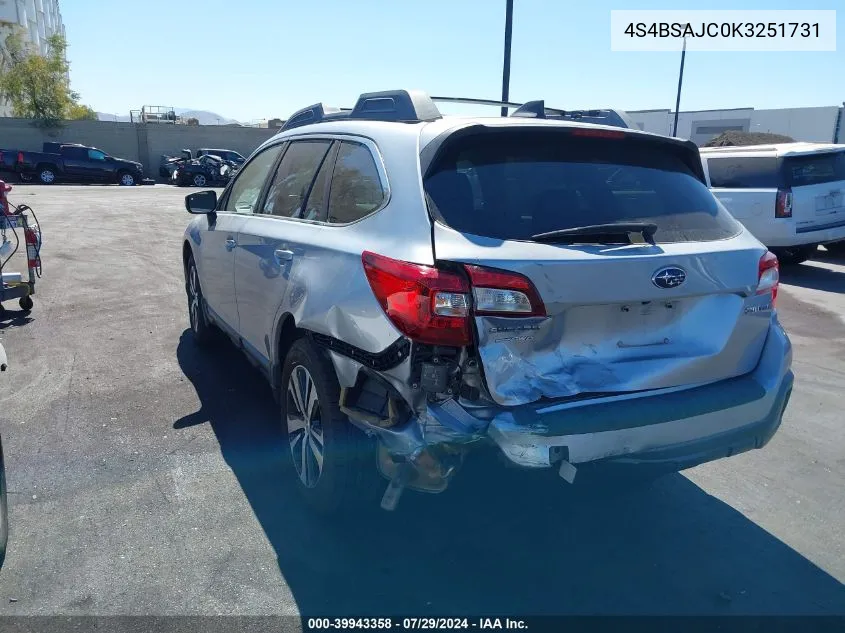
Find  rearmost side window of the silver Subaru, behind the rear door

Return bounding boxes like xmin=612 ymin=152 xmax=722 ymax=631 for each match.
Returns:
xmin=329 ymin=141 xmax=385 ymax=224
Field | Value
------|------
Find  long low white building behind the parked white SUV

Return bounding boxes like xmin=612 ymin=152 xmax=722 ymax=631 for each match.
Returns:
xmin=628 ymin=104 xmax=845 ymax=145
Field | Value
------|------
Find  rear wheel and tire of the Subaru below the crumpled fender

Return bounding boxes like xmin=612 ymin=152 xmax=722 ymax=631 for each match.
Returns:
xmin=279 ymin=338 xmax=378 ymax=515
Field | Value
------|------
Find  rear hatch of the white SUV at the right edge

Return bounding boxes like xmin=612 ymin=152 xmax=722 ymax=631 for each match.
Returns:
xmin=781 ymin=146 xmax=845 ymax=233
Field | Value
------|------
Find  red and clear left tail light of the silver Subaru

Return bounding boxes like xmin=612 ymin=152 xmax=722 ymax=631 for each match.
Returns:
xmin=361 ymin=251 xmax=546 ymax=347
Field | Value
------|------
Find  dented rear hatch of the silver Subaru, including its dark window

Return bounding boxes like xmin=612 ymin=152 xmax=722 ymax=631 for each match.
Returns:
xmin=424 ymin=126 xmax=772 ymax=405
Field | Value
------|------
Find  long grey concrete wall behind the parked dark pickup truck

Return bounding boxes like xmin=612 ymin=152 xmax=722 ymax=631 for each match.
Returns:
xmin=0 ymin=118 xmax=278 ymax=178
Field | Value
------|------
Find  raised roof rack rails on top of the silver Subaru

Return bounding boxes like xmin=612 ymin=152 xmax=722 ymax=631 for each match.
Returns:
xmin=281 ymin=90 xmax=637 ymax=132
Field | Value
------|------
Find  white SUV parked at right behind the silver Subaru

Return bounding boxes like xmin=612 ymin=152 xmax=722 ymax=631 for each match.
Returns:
xmin=700 ymin=143 xmax=845 ymax=264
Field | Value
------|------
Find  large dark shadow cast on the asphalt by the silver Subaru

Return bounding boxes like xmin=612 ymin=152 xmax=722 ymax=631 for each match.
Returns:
xmin=174 ymin=331 xmax=845 ymax=617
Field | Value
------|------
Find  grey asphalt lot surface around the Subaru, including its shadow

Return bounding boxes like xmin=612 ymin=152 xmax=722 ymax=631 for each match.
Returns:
xmin=0 ymin=186 xmax=845 ymax=616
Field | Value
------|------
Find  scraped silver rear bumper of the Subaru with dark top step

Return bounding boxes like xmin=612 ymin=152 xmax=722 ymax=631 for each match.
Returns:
xmin=487 ymin=321 xmax=793 ymax=469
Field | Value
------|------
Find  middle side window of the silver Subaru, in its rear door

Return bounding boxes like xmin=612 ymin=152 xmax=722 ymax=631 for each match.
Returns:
xmin=263 ymin=140 xmax=332 ymax=220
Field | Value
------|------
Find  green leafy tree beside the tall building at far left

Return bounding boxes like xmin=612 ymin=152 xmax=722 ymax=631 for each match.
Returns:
xmin=0 ymin=29 xmax=96 ymax=126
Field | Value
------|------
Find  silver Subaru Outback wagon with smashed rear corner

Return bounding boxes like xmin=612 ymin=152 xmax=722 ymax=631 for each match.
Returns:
xmin=183 ymin=91 xmax=793 ymax=512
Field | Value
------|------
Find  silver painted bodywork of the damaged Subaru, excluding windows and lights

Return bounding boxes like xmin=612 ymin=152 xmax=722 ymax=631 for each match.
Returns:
xmin=185 ymin=113 xmax=791 ymax=486
